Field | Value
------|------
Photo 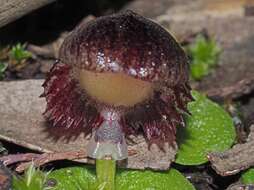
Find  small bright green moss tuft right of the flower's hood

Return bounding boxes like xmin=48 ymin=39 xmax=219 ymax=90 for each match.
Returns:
xmin=186 ymin=35 xmax=221 ymax=80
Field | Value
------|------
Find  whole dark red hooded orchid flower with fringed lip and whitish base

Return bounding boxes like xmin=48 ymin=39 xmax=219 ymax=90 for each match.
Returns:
xmin=43 ymin=11 xmax=192 ymax=160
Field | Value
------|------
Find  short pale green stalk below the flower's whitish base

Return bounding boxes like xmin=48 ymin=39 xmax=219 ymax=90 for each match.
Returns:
xmin=96 ymin=159 xmax=116 ymax=190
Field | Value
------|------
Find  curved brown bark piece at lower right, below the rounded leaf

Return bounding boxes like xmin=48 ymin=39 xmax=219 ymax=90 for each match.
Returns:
xmin=208 ymin=125 xmax=254 ymax=176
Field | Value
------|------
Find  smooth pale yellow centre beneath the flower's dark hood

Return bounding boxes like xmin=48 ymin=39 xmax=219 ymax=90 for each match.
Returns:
xmin=79 ymin=69 xmax=153 ymax=107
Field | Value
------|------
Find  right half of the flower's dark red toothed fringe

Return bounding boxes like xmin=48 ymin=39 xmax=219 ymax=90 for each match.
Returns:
xmin=123 ymin=84 xmax=193 ymax=150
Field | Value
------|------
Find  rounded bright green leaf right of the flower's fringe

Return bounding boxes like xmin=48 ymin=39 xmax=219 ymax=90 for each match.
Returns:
xmin=175 ymin=91 xmax=236 ymax=165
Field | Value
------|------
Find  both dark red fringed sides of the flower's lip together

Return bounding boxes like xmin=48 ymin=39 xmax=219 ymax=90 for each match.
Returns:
xmin=42 ymin=63 xmax=193 ymax=149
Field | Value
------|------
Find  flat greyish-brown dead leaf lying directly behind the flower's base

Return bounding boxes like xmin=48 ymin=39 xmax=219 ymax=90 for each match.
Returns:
xmin=0 ymin=80 xmax=177 ymax=170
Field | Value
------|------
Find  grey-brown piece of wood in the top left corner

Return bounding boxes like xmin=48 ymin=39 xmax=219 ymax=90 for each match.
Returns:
xmin=0 ymin=0 xmax=55 ymax=28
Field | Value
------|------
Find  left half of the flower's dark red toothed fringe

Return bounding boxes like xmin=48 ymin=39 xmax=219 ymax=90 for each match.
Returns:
xmin=42 ymin=63 xmax=101 ymax=141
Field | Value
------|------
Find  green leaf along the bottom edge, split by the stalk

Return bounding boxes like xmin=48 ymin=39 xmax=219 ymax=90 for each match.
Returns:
xmin=49 ymin=167 xmax=195 ymax=190
